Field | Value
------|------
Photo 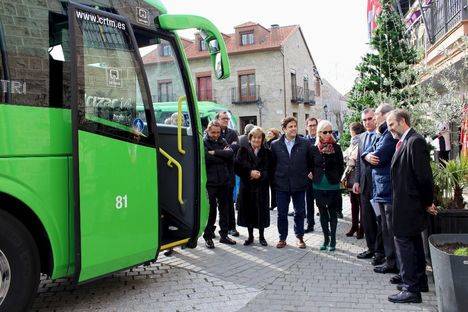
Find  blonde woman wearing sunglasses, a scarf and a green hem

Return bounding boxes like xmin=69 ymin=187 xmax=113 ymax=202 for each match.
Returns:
xmin=312 ymin=120 xmax=344 ymax=251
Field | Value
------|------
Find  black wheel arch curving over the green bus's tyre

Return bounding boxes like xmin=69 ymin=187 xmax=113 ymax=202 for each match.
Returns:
xmin=0 ymin=192 xmax=54 ymax=276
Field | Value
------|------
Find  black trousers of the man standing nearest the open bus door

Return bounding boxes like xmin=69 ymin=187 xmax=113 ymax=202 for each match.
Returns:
xmin=207 ymin=185 xmax=232 ymax=239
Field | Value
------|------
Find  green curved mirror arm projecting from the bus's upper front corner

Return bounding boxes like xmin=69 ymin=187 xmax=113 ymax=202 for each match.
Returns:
xmin=158 ymin=14 xmax=231 ymax=79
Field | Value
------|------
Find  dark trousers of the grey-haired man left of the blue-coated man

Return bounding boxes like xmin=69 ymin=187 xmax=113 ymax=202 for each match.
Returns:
xmin=361 ymin=190 xmax=384 ymax=256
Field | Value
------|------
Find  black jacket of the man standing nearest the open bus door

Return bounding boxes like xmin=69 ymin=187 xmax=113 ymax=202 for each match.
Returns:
xmin=203 ymin=136 xmax=234 ymax=186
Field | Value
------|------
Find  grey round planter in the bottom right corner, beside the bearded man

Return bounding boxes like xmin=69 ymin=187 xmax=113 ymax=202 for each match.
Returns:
xmin=429 ymin=234 xmax=468 ymax=312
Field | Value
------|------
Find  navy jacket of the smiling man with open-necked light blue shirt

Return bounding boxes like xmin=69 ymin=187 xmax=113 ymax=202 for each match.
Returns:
xmin=271 ymin=134 xmax=312 ymax=192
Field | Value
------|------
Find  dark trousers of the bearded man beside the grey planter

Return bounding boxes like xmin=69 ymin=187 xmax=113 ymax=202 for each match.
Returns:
xmin=395 ymin=234 xmax=427 ymax=292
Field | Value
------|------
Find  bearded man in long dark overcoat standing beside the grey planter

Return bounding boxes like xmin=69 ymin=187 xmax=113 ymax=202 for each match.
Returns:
xmin=387 ymin=109 xmax=437 ymax=303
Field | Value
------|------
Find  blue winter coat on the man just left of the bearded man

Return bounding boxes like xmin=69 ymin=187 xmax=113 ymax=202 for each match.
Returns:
xmin=361 ymin=123 xmax=398 ymax=204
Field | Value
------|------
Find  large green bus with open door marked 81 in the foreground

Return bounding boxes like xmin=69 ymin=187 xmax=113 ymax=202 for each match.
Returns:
xmin=0 ymin=0 xmax=230 ymax=311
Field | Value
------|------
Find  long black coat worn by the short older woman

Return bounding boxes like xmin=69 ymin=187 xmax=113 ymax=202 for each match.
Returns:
xmin=234 ymin=144 xmax=270 ymax=228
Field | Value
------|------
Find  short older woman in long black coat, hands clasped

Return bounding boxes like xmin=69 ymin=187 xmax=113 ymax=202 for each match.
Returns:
xmin=234 ymin=127 xmax=270 ymax=246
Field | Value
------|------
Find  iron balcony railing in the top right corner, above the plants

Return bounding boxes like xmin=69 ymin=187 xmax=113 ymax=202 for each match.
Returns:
xmin=423 ymin=0 xmax=468 ymax=44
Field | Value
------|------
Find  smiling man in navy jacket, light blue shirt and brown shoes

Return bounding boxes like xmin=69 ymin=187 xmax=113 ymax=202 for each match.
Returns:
xmin=271 ymin=117 xmax=312 ymax=248
